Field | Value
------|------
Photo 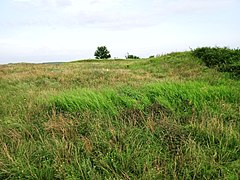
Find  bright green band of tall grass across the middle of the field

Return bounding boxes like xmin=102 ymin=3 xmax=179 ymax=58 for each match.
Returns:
xmin=50 ymin=82 xmax=240 ymax=119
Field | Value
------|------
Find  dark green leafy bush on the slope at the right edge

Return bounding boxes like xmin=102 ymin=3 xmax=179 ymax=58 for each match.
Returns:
xmin=192 ymin=47 xmax=240 ymax=77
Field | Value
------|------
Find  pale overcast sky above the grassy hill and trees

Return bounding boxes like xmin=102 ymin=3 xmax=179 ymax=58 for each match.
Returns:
xmin=0 ymin=0 xmax=240 ymax=64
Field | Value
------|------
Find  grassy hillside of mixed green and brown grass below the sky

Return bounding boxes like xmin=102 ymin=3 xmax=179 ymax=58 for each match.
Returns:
xmin=0 ymin=52 xmax=240 ymax=179
